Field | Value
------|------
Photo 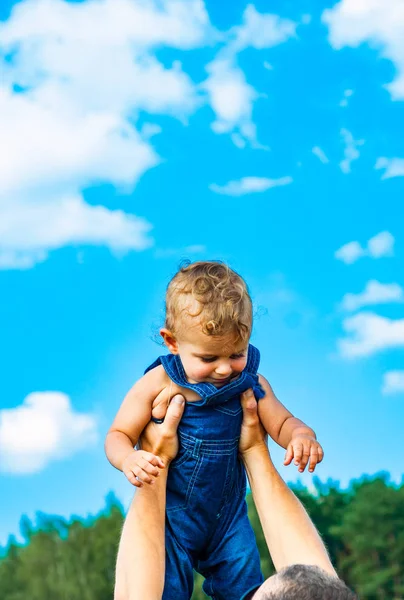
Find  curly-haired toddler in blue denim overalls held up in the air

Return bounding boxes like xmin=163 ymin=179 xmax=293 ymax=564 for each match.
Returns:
xmin=105 ymin=262 xmax=323 ymax=600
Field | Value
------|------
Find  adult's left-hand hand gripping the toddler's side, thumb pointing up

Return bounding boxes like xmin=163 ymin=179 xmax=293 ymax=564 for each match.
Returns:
xmin=139 ymin=394 xmax=185 ymax=466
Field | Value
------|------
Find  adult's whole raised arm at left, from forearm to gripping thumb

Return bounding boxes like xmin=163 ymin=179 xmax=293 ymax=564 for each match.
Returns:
xmin=114 ymin=395 xmax=184 ymax=600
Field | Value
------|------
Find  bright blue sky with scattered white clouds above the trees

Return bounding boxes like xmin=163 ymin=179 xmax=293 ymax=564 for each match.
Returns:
xmin=0 ymin=0 xmax=404 ymax=544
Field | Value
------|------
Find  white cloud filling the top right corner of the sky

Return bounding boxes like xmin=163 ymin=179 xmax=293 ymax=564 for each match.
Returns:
xmin=323 ymin=0 xmax=404 ymax=100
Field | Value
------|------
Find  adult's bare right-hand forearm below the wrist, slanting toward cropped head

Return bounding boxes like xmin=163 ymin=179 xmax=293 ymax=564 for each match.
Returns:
xmin=242 ymin=444 xmax=336 ymax=575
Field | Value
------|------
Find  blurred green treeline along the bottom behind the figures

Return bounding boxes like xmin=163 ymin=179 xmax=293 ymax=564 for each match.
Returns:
xmin=0 ymin=474 xmax=404 ymax=600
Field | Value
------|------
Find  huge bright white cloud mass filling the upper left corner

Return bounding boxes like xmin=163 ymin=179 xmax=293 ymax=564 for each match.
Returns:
xmin=0 ymin=0 xmax=211 ymax=268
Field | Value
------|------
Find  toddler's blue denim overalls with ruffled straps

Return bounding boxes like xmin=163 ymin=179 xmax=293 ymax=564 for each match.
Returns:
xmin=146 ymin=345 xmax=264 ymax=600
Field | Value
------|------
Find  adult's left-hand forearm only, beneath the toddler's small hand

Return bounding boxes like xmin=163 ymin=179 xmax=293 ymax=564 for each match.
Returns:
xmin=116 ymin=466 xmax=168 ymax=600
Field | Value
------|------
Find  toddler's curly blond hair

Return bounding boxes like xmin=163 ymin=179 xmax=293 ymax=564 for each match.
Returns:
xmin=165 ymin=261 xmax=252 ymax=342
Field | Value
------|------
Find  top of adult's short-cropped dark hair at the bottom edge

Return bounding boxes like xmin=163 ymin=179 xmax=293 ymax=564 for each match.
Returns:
xmin=267 ymin=565 xmax=358 ymax=600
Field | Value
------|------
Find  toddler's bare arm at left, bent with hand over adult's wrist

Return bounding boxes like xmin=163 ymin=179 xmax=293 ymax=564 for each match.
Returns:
xmin=105 ymin=366 xmax=167 ymax=487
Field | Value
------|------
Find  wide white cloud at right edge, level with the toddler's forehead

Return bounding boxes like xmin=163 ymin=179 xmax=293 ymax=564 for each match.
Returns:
xmin=338 ymin=312 xmax=404 ymax=358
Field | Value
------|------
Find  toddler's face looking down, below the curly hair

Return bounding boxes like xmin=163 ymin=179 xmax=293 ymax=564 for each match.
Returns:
xmin=177 ymin=327 xmax=248 ymax=387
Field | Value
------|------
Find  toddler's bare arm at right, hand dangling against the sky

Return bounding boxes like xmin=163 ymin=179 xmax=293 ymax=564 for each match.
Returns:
xmin=258 ymin=375 xmax=324 ymax=473
